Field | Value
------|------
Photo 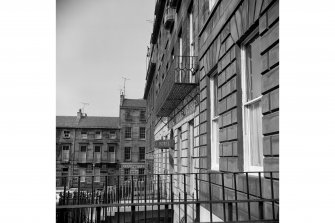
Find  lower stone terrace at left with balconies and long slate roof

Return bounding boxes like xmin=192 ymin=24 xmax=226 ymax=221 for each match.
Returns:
xmin=56 ymin=110 xmax=121 ymax=190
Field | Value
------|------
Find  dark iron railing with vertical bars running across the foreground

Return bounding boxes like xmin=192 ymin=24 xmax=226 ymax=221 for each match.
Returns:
xmin=56 ymin=172 xmax=279 ymax=223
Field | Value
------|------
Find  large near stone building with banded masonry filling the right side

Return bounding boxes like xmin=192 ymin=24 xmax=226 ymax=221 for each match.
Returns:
xmin=144 ymin=0 xmax=279 ymax=222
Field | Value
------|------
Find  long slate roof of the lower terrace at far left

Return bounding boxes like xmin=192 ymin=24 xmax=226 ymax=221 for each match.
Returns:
xmin=56 ymin=116 xmax=120 ymax=128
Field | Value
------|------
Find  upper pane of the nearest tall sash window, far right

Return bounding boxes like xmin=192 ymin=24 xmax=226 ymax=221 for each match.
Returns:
xmin=246 ymin=37 xmax=262 ymax=100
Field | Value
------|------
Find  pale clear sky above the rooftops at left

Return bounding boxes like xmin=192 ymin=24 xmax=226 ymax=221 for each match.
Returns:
xmin=56 ymin=0 xmax=155 ymax=116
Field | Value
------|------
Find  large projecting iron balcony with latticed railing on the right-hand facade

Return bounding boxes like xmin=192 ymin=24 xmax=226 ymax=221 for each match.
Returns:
xmin=155 ymin=56 xmax=199 ymax=117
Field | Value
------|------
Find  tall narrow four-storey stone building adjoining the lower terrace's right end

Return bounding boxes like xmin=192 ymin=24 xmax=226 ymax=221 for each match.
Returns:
xmin=120 ymin=94 xmax=146 ymax=181
